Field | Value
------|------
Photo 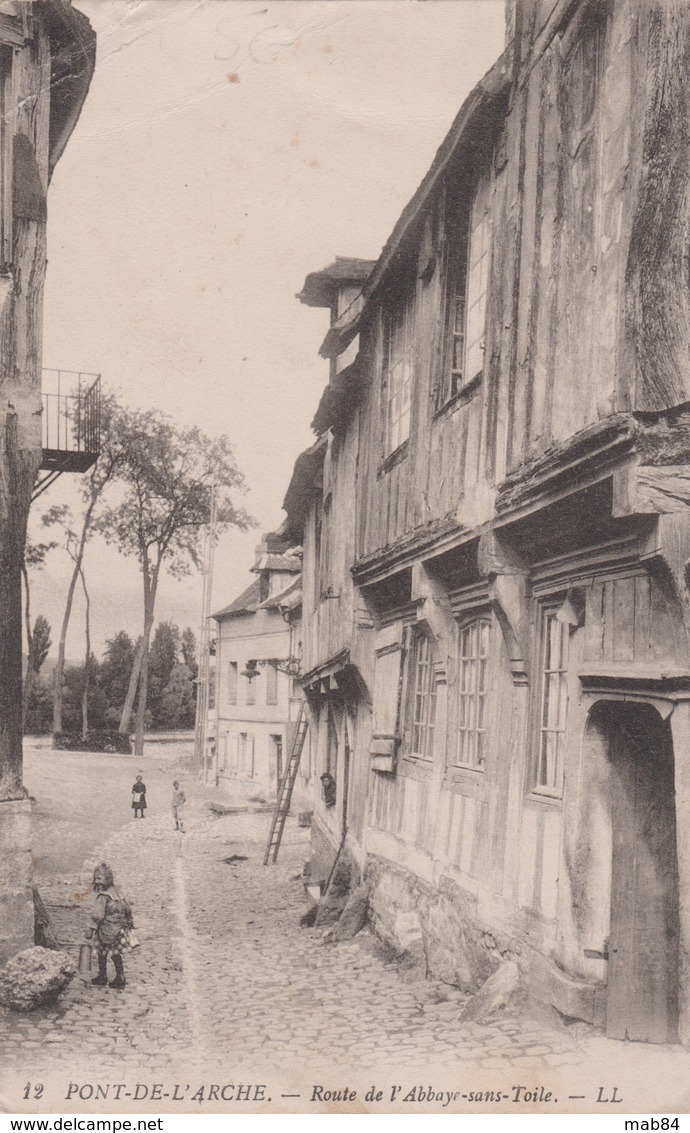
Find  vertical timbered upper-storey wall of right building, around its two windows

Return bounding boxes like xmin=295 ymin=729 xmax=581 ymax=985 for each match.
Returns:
xmin=351 ymin=0 xmax=661 ymax=566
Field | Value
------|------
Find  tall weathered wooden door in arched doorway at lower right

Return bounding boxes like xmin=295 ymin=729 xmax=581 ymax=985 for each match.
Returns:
xmin=606 ymin=705 xmax=679 ymax=1042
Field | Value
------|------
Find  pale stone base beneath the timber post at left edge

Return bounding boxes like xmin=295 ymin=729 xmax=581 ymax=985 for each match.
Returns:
xmin=0 ymin=799 xmax=34 ymax=965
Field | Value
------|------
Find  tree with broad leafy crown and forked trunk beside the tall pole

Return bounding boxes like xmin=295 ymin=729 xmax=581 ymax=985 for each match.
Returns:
xmin=97 ymin=410 xmax=253 ymax=756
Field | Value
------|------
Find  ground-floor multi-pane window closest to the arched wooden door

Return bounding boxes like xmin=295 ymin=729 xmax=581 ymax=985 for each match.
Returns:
xmin=535 ymin=610 xmax=570 ymax=795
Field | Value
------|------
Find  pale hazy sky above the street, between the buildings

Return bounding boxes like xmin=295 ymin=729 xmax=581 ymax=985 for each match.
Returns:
xmin=31 ymin=0 xmax=504 ymax=659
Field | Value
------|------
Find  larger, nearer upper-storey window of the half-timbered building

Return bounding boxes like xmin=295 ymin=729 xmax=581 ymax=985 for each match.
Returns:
xmin=434 ymin=172 xmax=491 ymax=409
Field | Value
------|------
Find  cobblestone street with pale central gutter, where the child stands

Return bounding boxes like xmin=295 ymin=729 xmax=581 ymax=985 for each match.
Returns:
xmin=0 ymin=747 xmax=690 ymax=1111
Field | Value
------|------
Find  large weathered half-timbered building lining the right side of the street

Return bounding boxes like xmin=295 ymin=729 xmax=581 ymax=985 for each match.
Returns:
xmin=279 ymin=0 xmax=690 ymax=1042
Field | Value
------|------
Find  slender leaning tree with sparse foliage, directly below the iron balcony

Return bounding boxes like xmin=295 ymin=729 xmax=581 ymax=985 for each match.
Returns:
xmin=43 ymin=394 xmax=123 ymax=732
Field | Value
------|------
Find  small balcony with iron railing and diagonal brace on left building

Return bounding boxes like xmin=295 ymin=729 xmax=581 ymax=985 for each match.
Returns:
xmin=33 ymin=369 xmax=101 ymax=500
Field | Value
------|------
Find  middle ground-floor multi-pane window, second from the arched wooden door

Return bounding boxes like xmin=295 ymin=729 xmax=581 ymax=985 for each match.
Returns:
xmin=457 ymin=617 xmax=491 ymax=768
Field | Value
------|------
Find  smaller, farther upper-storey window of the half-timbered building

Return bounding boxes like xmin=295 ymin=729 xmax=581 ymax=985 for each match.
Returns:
xmin=383 ymin=289 xmax=416 ymax=457
